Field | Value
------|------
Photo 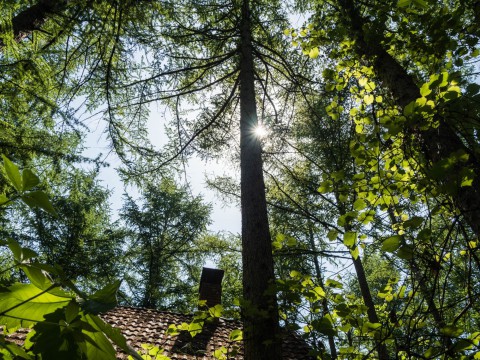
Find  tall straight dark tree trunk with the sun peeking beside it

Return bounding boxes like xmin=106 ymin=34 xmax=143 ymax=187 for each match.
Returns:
xmin=240 ymin=0 xmax=281 ymax=360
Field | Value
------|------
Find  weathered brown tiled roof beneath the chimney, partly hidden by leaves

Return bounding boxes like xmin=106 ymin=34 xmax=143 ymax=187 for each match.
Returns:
xmin=7 ymin=307 xmax=313 ymax=360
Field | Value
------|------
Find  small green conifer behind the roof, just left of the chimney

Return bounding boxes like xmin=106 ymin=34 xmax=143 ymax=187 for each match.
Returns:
xmin=120 ymin=178 xmax=210 ymax=312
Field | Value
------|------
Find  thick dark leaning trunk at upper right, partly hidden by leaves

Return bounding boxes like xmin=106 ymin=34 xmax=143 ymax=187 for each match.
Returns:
xmin=339 ymin=0 xmax=480 ymax=236
